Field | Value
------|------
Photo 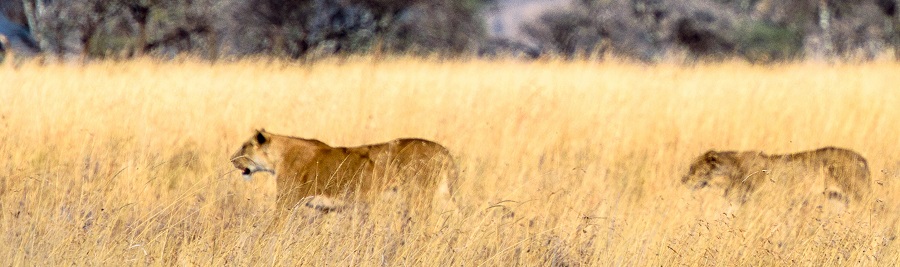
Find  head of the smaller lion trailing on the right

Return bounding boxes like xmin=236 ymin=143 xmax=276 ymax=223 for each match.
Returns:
xmin=681 ymin=151 xmax=739 ymax=193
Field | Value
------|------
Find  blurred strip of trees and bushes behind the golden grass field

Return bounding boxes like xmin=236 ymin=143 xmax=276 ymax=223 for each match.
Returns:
xmin=0 ymin=0 xmax=900 ymax=63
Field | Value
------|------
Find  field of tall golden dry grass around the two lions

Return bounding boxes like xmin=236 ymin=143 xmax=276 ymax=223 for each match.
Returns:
xmin=0 ymin=58 xmax=900 ymax=266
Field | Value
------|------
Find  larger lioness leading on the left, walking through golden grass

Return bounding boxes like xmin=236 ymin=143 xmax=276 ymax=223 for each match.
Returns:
xmin=231 ymin=130 xmax=456 ymax=216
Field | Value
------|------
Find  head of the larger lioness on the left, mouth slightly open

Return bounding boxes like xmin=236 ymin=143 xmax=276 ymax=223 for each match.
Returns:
xmin=231 ymin=129 xmax=275 ymax=180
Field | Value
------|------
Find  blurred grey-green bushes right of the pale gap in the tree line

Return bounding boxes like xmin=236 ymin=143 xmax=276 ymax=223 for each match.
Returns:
xmin=526 ymin=0 xmax=888 ymax=62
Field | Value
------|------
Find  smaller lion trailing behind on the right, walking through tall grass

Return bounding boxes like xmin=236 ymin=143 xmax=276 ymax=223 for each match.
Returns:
xmin=681 ymin=147 xmax=871 ymax=203
